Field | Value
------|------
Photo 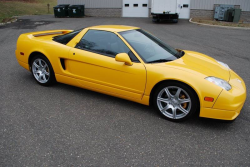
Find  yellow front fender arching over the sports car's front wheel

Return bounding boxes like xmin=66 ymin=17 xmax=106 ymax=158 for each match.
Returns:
xmin=145 ymin=64 xmax=222 ymax=108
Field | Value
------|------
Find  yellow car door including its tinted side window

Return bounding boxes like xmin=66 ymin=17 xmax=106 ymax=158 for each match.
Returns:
xmin=67 ymin=30 xmax=146 ymax=99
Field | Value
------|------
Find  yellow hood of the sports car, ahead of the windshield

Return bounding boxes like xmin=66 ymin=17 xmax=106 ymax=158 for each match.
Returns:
xmin=151 ymin=50 xmax=230 ymax=81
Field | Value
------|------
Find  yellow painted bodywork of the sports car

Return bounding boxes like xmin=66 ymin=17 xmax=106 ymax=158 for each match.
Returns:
xmin=16 ymin=25 xmax=246 ymax=120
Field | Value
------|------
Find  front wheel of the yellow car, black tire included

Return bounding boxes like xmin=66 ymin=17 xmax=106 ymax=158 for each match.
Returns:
xmin=152 ymin=81 xmax=199 ymax=122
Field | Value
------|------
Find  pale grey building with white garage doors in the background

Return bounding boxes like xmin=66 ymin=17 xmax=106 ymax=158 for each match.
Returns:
xmin=58 ymin=0 xmax=250 ymax=21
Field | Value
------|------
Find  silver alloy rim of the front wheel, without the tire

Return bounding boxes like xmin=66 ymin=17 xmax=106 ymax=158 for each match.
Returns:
xmin=157 ymin=86 xmax=192 ymax=119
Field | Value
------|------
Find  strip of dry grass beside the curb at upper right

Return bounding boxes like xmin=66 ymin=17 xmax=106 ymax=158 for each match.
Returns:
xmin=192 ymin=18 xmax=250 ymax=27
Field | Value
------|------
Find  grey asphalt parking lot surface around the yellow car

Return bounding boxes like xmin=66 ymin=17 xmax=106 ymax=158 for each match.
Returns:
xmin=0 ymin=15 xmax=250 ymax=166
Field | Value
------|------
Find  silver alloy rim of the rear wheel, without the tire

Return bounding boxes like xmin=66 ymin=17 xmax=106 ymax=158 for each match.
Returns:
xmin=32 ymin=58 xmax=50 ymax=83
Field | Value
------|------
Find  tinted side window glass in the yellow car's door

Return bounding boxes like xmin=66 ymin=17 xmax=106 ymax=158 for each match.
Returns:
xmin=76 ymin=30 xmax=139 ymax=62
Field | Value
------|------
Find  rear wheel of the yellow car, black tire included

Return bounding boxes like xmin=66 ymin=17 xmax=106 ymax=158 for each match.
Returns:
xmin=30 ymin=54 xmax=56 ymax=86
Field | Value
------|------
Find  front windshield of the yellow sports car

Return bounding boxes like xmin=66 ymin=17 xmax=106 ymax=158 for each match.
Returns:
xmin=120 ymin=29 xmax=183 ymax=63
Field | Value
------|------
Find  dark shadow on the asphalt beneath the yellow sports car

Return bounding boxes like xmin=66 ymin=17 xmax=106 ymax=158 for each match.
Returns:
xmin=25 ymin=75 xmax=236 ymax=130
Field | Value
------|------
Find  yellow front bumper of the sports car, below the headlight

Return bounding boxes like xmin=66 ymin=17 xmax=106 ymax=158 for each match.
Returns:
xmin=200 ymin=70 xmax=247 ymax=120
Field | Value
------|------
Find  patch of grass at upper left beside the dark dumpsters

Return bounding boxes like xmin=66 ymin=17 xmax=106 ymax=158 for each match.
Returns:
xmin=0 ymin=0 xmax=57 ymax=22
